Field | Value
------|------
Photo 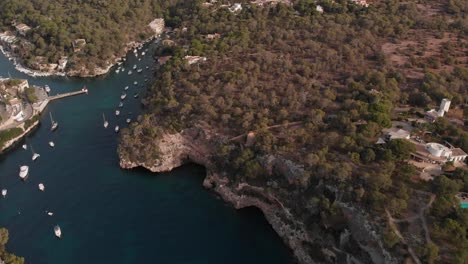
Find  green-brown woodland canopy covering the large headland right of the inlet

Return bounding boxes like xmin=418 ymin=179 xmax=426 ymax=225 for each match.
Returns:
xmin=121 ymin=0 xmax=468 ymax=263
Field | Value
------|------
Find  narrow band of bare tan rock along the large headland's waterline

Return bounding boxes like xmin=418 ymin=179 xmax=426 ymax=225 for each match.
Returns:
xmin=119 ymin=127 xmax=314 ymax=264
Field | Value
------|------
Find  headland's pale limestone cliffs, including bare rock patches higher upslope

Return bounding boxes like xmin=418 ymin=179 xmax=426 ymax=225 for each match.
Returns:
xmin=119 ymin=127 xmax=399 ymax=264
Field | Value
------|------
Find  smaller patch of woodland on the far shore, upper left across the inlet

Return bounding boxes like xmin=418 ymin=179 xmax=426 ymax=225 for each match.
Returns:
xmin=0 ymin=0 xmax=176 ymax=69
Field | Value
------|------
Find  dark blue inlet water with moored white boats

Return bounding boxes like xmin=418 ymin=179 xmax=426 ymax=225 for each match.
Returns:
xmin=0 ymin=43 xmax=291 ymax=264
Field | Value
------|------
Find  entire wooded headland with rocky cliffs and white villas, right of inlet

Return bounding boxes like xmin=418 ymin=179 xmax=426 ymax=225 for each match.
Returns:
xmin=118 ymin=0 xmax=468 ymax=263
